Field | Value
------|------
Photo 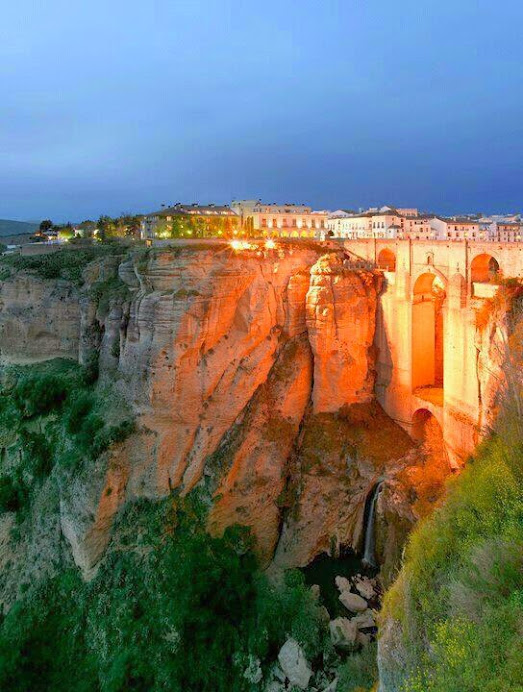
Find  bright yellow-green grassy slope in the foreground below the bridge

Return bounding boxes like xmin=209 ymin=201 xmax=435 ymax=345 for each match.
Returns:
xmin=384 ymin=425 xmax=523 ymax=692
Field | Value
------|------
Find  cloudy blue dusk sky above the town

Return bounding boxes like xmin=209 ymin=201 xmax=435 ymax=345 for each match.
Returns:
xmin=0 ymin=0 xmax=523 ymax=221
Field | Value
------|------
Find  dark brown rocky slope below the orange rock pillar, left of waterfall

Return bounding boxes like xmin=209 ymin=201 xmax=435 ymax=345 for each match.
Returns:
xmin=275 ymin=402 xmax=418 ymax=567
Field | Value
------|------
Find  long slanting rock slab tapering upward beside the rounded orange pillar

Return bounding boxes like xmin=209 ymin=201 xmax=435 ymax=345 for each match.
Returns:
xmin=209 ymin=336 xmax=312 ymax=565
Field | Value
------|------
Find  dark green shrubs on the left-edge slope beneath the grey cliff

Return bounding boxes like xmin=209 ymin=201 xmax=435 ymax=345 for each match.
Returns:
xmin=0 ymin=360 xmax=133 ymax=521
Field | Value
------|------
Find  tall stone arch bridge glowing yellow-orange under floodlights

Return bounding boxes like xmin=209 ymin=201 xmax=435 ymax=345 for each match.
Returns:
xmin=342 ymin=239 xmax=523 ymax=465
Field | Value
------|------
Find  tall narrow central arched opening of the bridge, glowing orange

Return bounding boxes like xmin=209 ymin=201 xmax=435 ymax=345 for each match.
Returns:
xmin=412 ymin=273 xmax=446 ymax=405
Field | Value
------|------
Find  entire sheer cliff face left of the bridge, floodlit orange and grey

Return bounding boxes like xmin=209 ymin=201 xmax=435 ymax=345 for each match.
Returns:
xmin=0 ymin=245 xmax=436 ymax=575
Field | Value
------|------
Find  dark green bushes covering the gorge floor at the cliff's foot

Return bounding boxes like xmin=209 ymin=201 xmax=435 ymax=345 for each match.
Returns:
xmin=0 ymin=498 xmax=327 ymax=692
